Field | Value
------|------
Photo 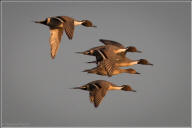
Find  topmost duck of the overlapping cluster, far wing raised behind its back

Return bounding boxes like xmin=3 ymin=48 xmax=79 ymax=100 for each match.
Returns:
xmin=77 ymin=39 xmax=141 ymax=56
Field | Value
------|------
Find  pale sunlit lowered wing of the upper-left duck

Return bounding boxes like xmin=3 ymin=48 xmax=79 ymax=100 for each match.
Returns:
xmin=49 ymin=28 xmax=63 ymax=59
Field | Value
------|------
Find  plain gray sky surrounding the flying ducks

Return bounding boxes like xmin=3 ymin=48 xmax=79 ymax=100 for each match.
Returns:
xmin=2 ymin=2 xmax=191 ymax=126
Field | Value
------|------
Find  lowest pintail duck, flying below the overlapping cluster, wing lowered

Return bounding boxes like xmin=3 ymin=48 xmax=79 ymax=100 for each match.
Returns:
xmin=73 ymin=80 xmax=136 ymax=107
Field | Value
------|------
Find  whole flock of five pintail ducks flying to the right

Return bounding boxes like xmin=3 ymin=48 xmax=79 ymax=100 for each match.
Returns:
xmin=35 ymin=16 xmax=153 ymax=107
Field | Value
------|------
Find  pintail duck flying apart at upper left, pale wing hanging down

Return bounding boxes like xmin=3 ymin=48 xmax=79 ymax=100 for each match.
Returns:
xmin=35 ymin=16 xmax=96 ymax=59
